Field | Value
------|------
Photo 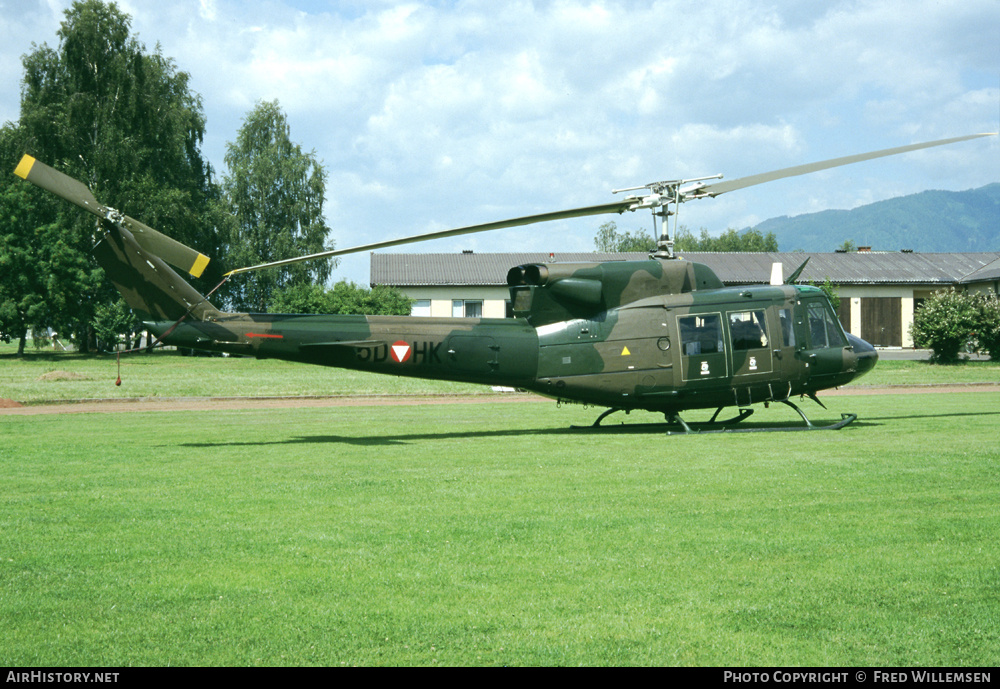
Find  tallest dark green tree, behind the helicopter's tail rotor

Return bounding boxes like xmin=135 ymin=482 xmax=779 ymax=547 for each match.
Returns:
xmin=5 ymin=0 xmax=219 ymax=350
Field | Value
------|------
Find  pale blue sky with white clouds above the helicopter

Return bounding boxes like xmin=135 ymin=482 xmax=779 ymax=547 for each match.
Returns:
xmin=0 ymin=0 xmax=1000 ymax=284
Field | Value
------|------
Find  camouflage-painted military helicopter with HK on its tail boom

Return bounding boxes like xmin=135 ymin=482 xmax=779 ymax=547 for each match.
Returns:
xmin=15 ymin=134 xmax=989 ymax=432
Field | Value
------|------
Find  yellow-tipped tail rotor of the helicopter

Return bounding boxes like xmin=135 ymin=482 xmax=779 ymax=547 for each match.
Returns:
xmin=14 ymin=155 xmax=209 ymax=277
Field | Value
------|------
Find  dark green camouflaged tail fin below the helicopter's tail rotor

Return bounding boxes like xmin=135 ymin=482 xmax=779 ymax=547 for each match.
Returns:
xmin=93 ymin=226 xmax=222 ymax=321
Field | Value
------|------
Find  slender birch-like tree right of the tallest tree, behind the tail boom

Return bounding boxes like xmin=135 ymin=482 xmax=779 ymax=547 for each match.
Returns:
xmin=222 ymin=101 xmax=332 ymax=312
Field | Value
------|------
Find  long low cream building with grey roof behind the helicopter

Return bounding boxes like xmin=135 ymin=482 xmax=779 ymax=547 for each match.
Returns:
xmin=371 ymin=251 xmax=1000 ymax=347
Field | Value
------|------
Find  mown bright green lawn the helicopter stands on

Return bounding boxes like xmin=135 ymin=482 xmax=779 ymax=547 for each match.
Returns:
xmin=0 ymin=390 xmax=1000 ymax=666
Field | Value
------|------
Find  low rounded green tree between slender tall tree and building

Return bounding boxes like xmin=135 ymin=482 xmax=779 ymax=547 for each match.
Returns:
xmin=270 ymin=280 xmax=413 ymax=316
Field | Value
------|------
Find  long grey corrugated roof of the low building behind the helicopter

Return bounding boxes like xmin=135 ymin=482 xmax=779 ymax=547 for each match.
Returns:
xmin=371 ymin=251 xmax=1000 ymax=287
